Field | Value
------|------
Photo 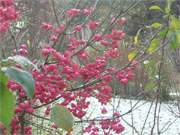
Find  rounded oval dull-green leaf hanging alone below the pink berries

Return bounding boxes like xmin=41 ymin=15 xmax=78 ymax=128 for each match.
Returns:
xmin=51 ymin=104 xmax=74 ymax=132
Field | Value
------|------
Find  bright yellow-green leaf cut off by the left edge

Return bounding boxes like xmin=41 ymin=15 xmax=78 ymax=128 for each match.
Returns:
xmin=0 ymin=71 xmax=15 ymax=129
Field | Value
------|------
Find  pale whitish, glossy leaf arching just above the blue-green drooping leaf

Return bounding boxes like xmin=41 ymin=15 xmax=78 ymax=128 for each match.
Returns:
xmin=7 ymin=55 xmax=37 ymax=69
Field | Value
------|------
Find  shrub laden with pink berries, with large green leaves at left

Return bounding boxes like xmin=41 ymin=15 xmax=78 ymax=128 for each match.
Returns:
xmin=0 ymin=0 xmax=170 ymax=135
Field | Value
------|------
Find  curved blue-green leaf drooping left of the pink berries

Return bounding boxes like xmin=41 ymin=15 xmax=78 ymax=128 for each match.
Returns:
xmin=2 ymin=67 xmax=34 ymax=99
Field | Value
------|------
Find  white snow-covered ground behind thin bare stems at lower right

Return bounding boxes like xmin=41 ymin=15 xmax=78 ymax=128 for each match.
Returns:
xmin=74 ymin=98 xmax=180 ymax=135
